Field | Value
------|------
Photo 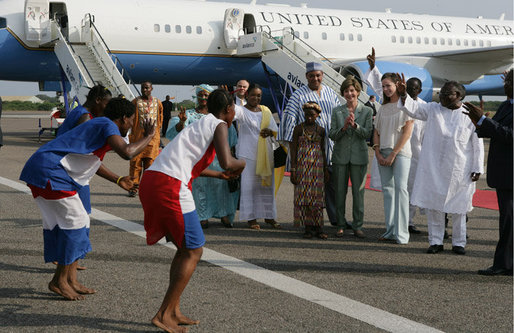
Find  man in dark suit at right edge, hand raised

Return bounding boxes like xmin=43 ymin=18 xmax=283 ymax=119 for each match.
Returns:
xmin=465 ymin=69 xmax=513 ymax=275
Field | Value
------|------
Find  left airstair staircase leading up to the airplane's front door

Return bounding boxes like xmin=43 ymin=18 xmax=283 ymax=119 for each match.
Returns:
xmin=51 ymin=14 xmax=138 ymax=101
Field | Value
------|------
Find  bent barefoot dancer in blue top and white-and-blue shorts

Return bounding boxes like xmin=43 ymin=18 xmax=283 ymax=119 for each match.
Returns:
xmin=20 ymin=98 xmax=155 ymax=300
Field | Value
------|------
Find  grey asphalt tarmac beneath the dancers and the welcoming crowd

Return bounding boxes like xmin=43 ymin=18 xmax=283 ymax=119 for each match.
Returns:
xmin=0 ymin=112 xmax=513 ymax=332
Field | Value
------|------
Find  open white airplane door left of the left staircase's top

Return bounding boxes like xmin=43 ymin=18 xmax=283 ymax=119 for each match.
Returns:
xmin=25 ymin=0 xmax=51 ymax=45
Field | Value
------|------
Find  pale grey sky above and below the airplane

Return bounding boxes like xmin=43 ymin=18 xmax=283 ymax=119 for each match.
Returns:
xmin=0 ymin=0 xmax=513 ymax=101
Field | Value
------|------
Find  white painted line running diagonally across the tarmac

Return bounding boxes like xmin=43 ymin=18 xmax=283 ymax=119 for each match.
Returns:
xmin=0 ymin=177 xmax=442 ymax=333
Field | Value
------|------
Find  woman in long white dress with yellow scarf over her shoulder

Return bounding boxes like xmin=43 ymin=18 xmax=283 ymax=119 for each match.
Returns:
xmin=236 ymin=84 xmax=281 ymax=230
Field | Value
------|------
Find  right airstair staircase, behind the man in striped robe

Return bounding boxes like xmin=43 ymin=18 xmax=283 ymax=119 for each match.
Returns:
xmin=235 ymin=28 xmax=369 ymax=104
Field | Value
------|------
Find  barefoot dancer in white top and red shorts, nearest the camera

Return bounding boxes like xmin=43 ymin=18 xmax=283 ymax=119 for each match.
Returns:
xmin=139 ymin=90 xmax=245 ymax=333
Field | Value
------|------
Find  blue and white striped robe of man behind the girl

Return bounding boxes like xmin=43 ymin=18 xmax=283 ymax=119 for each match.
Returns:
xmin=278 ymin=84 xmax=341 ymax=165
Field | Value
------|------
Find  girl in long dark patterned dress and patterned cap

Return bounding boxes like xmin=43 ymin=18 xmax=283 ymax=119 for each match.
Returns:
xmin=290 ymin=102 xmax=328 ymax=239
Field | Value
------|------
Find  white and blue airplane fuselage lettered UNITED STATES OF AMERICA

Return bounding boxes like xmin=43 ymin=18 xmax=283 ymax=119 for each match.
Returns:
xmin=0 ymin=0 xmax=514 ymax=93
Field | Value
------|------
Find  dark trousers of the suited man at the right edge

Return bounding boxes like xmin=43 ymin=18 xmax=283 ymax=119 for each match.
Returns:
xmin=493 ymin=189 xmax=512 ymax=270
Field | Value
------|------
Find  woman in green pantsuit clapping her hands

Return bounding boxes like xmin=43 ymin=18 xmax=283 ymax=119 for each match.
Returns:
xmin=329 ymin=75 xmax=373 ymax=238
